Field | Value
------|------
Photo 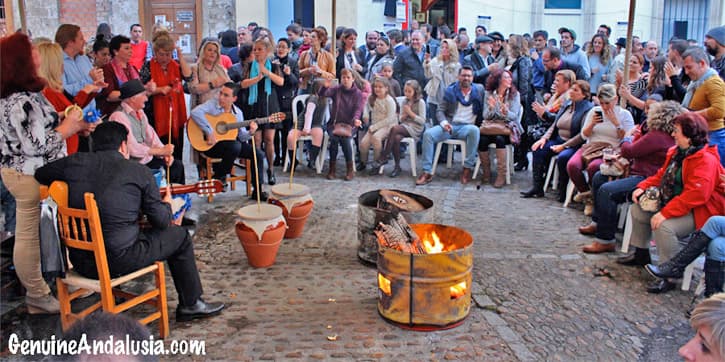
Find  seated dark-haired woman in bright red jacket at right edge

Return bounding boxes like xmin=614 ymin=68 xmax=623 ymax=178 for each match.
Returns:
xmin=617 ymin=112 xmax=725 ymax=293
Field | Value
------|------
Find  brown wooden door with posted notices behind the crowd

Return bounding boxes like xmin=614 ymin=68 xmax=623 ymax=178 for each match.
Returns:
xmin=145 ymin=0 xmax=201 ymax=59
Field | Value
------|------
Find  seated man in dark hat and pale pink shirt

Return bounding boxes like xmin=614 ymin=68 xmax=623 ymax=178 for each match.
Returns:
xmin=109 ymin=79 xmax=185 ymax=184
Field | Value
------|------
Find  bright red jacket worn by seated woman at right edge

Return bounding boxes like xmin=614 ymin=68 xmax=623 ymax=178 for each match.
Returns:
xmin=637 ymin=146 xmax=725 ymax=229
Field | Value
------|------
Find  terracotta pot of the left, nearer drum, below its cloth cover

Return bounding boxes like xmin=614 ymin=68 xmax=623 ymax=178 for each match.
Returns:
xmin=235 ymin=222 xmax=285 ymax=268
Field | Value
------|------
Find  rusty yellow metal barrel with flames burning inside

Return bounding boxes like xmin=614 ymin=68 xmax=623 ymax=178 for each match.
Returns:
xmin=377 ymin=224 xmax=473 ymax=330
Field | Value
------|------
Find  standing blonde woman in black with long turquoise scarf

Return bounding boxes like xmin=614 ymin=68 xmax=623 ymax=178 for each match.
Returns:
xmin=242 ymin=38 xmax=285 ymax=185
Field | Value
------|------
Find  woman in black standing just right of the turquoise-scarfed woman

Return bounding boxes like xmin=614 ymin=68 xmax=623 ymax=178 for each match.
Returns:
xmin=272 ymin=38 xmax=300 ymax=166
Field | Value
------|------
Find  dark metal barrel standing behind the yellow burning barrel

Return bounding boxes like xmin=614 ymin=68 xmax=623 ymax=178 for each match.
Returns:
xmin=357 ymin=190 xmax=433 ymax=264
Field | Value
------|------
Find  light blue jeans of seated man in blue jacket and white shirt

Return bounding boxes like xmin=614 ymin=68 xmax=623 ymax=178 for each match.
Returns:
xmin=423 ymin=124 xmax=481 ymax=173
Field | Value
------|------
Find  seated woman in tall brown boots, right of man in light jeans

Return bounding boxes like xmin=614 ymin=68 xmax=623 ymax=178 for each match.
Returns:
xmin=478 ymin=69 xmax=522 ymax=188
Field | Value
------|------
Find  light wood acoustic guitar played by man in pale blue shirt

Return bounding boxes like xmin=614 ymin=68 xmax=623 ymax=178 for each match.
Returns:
xmin=186 ymin=112 xmax=286 ymax=152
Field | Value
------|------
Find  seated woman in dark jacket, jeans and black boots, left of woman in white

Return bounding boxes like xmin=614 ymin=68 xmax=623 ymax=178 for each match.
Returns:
xmin=521 ymin=80 xmax=594 ymax=202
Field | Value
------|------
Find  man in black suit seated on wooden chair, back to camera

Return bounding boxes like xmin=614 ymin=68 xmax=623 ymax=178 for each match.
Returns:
xmin=35 ymin=122 xmax=224 ymax=322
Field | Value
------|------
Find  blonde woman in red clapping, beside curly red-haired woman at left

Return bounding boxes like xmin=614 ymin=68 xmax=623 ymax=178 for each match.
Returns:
xmin=36 ymin=42 xmax=105 ymax=155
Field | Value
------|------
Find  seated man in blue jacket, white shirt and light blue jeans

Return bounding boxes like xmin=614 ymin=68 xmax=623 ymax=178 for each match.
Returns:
xmin=415 ymin=65 xmax=484 ymax=185
